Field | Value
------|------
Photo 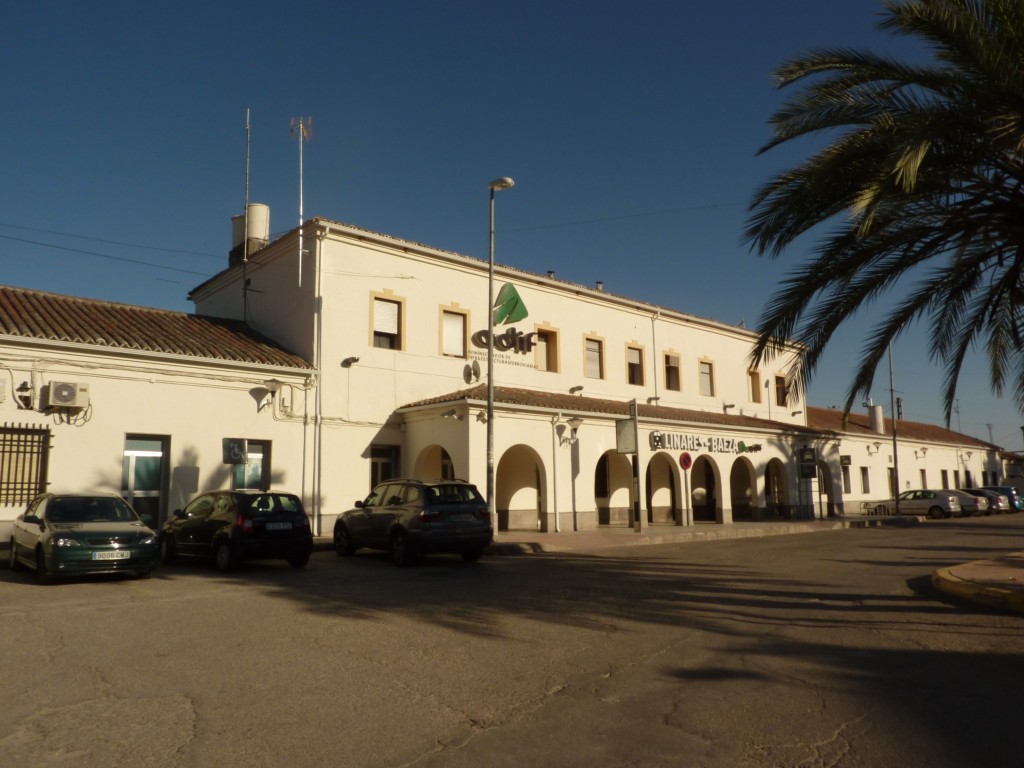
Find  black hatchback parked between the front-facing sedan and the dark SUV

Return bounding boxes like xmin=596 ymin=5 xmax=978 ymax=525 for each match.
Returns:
xmin=160 ymin=490 xmax=313 ymax=571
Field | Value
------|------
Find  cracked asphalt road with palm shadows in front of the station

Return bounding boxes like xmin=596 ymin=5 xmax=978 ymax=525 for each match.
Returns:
xmin=0 ymin=515 xmax=1024 ymax=768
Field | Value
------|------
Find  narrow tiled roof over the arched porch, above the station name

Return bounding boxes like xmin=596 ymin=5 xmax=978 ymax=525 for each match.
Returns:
xmin=399 ymin=384 xmax=820 ymax=433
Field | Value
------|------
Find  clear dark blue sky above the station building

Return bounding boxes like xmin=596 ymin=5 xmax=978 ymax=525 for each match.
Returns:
xmin=0 ymin=0 xmax=1024 ymax=450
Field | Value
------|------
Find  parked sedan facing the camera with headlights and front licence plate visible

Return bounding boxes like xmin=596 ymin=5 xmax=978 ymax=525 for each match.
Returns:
xmin=10 ymin=494 xmax=157 ymax=584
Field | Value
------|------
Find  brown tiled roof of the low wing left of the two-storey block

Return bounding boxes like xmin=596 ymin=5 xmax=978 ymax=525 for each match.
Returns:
xmin=0 ymin=286 xmax=311 ymax=369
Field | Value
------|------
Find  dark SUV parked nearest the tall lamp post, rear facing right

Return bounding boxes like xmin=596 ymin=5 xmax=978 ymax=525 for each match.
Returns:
xmin=334 ymin=479 xmax=494 ymax=566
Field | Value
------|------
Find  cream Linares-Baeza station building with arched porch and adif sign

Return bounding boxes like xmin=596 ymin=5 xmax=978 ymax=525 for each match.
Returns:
xmin=0 ymin=207 xmax=1007 ymax=541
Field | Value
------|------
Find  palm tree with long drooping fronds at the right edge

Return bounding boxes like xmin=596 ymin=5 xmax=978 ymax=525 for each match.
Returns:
xmin=744 ymin=0 xmax=1024 ymax=425
